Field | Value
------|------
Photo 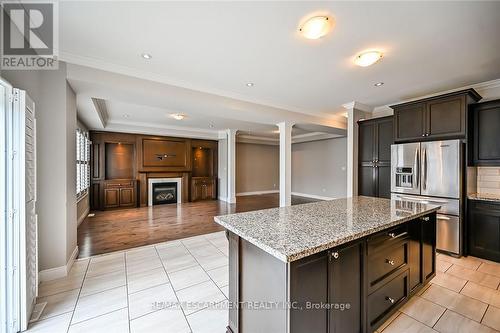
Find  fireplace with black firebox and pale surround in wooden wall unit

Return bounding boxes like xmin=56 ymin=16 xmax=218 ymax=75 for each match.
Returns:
xmin=148 ymin=178 xmax=182 ymax=206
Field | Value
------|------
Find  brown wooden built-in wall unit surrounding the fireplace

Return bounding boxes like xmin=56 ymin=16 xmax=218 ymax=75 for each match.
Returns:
xmin=90 ymin=131 xmax=217 ymax=210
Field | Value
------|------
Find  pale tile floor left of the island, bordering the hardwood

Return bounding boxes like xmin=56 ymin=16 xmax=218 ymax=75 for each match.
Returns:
xmin=28 ymin=232 xmax=229 ymax=333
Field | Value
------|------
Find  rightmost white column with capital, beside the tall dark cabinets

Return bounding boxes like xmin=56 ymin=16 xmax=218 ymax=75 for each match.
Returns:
xmin=342 ymin=102 xmax=371 ymax=197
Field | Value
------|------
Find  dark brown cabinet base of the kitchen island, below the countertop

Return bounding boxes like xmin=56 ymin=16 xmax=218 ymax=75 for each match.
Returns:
xmin=227 ymin=213 xmax=436 ymax=333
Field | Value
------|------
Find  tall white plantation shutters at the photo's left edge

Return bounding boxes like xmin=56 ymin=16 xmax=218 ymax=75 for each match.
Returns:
xmin=0 ymin=79 xmax=38 ymax=332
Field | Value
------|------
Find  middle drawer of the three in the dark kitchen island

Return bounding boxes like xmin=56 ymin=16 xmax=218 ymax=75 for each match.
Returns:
xmin=367 ymin=241 xmax=408 ymax=288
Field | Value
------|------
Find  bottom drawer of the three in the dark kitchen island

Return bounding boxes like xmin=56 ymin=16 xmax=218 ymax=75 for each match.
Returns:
xmin=367 ymin=270 xmax=408 ymax=331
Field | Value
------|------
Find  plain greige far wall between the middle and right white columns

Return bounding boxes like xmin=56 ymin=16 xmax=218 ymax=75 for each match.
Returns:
xmin=292 ymin=137 xmax=347 ymax=198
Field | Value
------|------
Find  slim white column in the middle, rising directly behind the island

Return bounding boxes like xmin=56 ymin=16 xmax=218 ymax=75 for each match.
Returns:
xmin=278 ymin=121 xmax=293 ymax=207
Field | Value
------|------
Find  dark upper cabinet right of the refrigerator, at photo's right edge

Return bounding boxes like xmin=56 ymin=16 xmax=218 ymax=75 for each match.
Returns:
xmin=472 ymin=100 xmax=500 ymax=166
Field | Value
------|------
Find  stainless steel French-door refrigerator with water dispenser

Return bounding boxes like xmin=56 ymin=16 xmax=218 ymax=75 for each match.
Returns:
xmin=391 ymin=140 xmax=463 ymax=255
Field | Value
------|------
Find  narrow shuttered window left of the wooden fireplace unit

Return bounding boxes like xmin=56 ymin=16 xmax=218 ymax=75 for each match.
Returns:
xmin=76 ymin=129 xmax=90 ymax=198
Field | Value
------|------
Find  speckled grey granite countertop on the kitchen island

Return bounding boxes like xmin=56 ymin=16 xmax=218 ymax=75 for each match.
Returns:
xmin=214 ymin=196 xmax=440 ymax=262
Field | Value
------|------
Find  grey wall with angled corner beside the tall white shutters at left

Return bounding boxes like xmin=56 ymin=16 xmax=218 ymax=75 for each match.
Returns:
xmin=2 ymin=62 xmax=76 ymax=272
